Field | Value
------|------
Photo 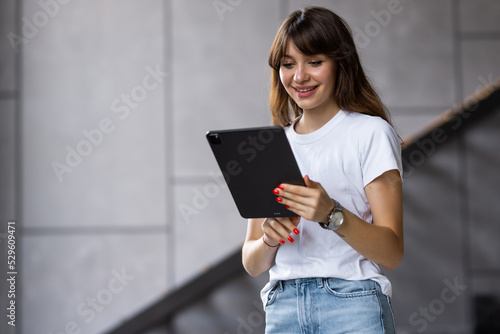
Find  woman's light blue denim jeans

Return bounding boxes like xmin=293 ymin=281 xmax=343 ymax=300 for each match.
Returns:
xmin=265 ymin=278 xmax=396 ymax=334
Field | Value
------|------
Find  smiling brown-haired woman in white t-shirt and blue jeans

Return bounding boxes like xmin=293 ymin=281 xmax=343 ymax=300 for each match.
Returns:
xmin=243 ymin=7 xmax=404 ymax=334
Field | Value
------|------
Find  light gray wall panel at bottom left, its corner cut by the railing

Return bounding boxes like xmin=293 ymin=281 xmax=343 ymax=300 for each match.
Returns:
xmin=19 ymin=234 xmax=167 ymax=333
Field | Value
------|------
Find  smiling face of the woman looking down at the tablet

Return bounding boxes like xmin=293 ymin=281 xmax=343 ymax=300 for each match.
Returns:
xmin=280 ymin=42 xmax=336 ymax=111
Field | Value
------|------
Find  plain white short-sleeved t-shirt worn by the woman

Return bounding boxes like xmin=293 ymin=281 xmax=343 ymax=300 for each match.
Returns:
xmin=261 ymin=110 xmax=403 ymax=305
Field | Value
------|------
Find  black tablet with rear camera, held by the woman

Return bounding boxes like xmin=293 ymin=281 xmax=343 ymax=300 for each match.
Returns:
xmin=206 ymin=126 xmax=305 ymax=218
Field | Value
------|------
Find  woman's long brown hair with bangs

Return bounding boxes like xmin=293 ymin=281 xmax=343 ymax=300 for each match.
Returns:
xmin=268 ymin=6 xmax=391 ymax=126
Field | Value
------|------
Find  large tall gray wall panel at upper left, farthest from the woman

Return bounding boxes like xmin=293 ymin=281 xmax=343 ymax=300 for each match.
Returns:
xmin=22 ymin=1 xmax=166 ymax=227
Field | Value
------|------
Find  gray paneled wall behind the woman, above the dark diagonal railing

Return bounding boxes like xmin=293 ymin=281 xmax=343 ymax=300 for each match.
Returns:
xmin=0 ymin=0 xmax=500 ymax=333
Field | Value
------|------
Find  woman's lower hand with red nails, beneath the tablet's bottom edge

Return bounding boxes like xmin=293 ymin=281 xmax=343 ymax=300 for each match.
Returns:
xmin=261 ymin=217 xmax=300 ymax=245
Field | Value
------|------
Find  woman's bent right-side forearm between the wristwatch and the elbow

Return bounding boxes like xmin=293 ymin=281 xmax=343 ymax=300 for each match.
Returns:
xmin=336 ymin=208 xmax=404 ymax=270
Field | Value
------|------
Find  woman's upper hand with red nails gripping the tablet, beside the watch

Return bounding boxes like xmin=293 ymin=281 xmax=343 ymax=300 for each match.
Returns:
xmin=273 ymin=175 xmax=335 ymax=223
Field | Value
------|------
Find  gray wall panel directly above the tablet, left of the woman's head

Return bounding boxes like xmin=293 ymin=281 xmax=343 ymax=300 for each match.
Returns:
xmin=172 ymin=0 xmax=279 ymax=177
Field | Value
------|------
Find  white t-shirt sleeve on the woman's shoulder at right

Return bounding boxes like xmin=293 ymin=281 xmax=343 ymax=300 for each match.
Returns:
xmin=358 ymin=117 xmax=403 ymax=187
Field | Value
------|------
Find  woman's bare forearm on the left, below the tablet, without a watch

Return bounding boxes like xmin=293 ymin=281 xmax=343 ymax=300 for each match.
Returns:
xmin=242 ymin=238 xmax=279 ymax=277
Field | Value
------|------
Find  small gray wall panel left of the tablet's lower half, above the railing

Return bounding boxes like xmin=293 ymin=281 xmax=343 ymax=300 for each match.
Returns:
xmin=173 ymin=179 xmax=247 ymax=284
